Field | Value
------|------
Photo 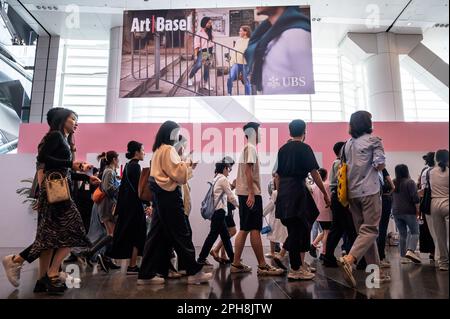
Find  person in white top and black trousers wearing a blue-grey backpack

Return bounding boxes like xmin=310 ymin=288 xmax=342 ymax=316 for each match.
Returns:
xmin=197 ymin=157 xmax=239 ymax=265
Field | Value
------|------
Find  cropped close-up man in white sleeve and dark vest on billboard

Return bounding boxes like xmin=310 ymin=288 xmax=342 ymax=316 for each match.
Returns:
xmin=245 ymin=7 xmax=314 ymax=94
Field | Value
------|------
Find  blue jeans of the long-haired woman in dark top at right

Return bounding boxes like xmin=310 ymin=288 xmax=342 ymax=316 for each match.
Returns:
xmin=394 ymin=214 xmax=419 ymax=257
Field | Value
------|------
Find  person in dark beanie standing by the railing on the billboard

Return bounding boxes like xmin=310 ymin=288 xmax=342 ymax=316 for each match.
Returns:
xmin=188 ymin=17 xmax=214 ymax=91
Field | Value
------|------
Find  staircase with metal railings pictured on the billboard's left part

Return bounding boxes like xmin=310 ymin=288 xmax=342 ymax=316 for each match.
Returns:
xmin=120 ymin=30 xmax=250 ymax=98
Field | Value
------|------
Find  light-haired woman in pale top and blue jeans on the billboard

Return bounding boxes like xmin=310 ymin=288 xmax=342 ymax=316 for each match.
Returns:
xmin=227 ymin=25 xmax=252 ymax=95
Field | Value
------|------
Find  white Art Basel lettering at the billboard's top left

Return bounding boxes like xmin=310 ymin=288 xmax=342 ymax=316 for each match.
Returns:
xmin=131 ymin=15 xmax=191 ymax=33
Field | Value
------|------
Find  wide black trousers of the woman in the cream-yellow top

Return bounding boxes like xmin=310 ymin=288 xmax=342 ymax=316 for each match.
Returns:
xmin=139 ymin=180 xmax=202 ymax=279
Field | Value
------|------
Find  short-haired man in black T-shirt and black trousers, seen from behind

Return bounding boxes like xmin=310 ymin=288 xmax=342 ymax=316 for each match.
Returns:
xmin=275 ymin=120 xmax=330 ymax=280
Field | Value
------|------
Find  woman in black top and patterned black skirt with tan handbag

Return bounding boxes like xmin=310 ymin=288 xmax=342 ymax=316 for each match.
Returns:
xmin=29 ymin=109 xmax=92 ymax=294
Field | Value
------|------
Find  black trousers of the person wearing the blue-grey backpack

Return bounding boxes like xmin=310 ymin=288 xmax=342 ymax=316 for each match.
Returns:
xmin=198 ymin=209 xmax=234 ymax=261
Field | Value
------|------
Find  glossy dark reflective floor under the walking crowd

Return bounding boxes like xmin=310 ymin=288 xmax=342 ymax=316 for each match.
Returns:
xmin=0 ymin=247 xmax=449 ymax=299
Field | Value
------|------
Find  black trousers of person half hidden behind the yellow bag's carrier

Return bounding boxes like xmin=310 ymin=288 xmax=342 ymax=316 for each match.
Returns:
xmin=325 ymin=192 xmax=356 ymax=262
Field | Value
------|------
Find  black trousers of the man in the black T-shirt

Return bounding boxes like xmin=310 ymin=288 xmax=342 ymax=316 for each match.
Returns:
xmin=281 ymin=217 xmax=311 ymax=270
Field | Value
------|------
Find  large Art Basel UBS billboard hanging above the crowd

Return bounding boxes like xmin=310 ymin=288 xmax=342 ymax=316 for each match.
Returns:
xmin=120 ymin=6 xmax=314 ymax=98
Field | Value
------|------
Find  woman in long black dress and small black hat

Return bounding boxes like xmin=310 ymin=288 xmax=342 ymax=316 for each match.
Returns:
xmin=109 ymin=141 xmax=147 ymax=275
